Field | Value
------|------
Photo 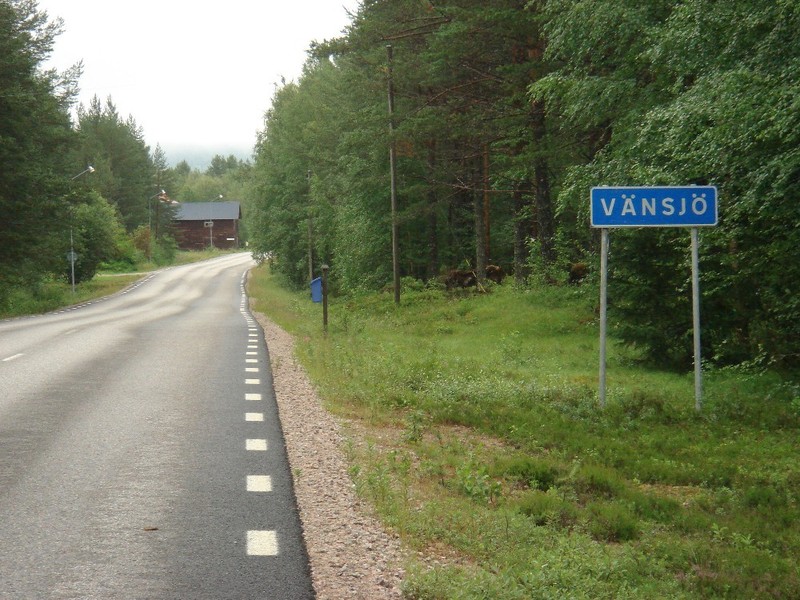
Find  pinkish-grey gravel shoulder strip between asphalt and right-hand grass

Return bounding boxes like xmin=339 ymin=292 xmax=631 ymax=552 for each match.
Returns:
xmin=254 ymin=312 xmax=404 ymax=600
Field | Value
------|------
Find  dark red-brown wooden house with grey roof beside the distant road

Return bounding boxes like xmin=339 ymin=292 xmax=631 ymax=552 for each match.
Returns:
xmin=172 ymin=202 xmax=242 ymax=250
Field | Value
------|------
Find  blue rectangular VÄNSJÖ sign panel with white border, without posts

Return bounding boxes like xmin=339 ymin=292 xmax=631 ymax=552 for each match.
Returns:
xmin=591 ymin=185 xmax=717 ymax=227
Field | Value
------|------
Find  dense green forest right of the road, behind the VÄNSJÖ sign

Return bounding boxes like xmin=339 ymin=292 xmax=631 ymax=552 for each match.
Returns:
xmin=252 ymin=0 xmax=800 ymax=368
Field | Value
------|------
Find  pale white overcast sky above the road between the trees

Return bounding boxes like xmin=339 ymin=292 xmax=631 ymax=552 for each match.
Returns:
xmin=38 ymin=0 xmax=359 ymax=168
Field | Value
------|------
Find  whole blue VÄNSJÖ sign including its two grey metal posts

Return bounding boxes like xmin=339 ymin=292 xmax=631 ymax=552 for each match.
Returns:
xmin=590 ymin=186 xmax=718 ymax=411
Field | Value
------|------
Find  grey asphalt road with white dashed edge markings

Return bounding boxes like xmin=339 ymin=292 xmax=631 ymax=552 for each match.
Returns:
xmin=0 ymin=254 xmax=314 ymax=600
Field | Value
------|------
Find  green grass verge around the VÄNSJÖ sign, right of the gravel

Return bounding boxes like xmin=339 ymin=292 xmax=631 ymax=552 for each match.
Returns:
xmin=249 ymin=267 xmax=800 ymax=599
